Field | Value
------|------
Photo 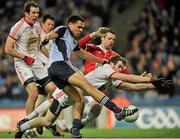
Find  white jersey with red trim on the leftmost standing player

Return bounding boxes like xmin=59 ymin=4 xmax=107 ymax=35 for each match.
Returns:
xmin=9 ymin=18 xmax=40 ymax=57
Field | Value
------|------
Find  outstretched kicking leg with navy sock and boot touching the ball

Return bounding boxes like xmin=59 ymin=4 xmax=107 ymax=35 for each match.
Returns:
xmin=68 ymin=72 xmax=138 ymax=120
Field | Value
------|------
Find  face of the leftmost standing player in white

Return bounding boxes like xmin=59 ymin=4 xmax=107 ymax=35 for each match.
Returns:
xmin=25 ymin=7 xmax=39 ymax=24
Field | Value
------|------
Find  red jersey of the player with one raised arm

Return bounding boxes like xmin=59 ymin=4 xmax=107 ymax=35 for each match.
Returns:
xmin=78 ymin=35 xmax=128 ymax=75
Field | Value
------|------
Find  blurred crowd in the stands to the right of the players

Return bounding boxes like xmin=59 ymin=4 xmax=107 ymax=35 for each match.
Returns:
xmin=125 ymin=0 xmax=180 ymax=98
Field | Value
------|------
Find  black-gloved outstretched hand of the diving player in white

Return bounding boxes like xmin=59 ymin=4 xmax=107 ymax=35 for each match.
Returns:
xmin=150 ymin=78 xmax=173 ymax=91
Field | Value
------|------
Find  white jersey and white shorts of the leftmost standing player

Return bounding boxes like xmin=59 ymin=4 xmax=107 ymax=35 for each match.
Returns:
xmin=9 ymin=18 xmax=48 ymax=84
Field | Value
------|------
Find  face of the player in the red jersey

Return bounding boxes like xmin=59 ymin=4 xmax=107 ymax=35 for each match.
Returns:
xmin=101 ymin=32 xmax=116 ymax=50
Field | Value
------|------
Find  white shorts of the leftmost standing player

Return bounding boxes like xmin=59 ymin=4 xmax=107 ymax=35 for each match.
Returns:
xmin=14 ymin=58 xmax=48 ymax=84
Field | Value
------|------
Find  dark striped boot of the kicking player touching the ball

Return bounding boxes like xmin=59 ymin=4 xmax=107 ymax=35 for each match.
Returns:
xmin=115 ymin=107 xmax=138 ymax=121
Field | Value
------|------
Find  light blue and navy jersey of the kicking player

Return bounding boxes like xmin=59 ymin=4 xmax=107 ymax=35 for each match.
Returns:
xmin=49 ymin=26 xmax=80 ymax=65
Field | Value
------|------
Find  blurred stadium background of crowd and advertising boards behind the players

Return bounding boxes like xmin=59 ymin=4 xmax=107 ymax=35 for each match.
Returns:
xmin=0 ymin=0 xmax=180 ymax=136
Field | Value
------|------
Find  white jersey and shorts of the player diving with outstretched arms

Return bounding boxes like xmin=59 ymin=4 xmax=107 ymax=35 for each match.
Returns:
xmin=53 ymin=64 xmax=123 ymax=106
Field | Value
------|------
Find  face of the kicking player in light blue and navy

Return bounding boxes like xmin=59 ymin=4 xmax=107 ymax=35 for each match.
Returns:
xmin=68 ymin=20 xmax=85 ymax=37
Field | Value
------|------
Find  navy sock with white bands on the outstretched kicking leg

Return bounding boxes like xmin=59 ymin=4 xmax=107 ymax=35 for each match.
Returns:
xmin=100 ymin=96 xmax=122 ymax=113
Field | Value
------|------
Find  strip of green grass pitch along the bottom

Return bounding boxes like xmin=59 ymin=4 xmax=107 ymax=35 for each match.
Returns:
xmin=0 ymin=128 xmax=180 ymax=138
